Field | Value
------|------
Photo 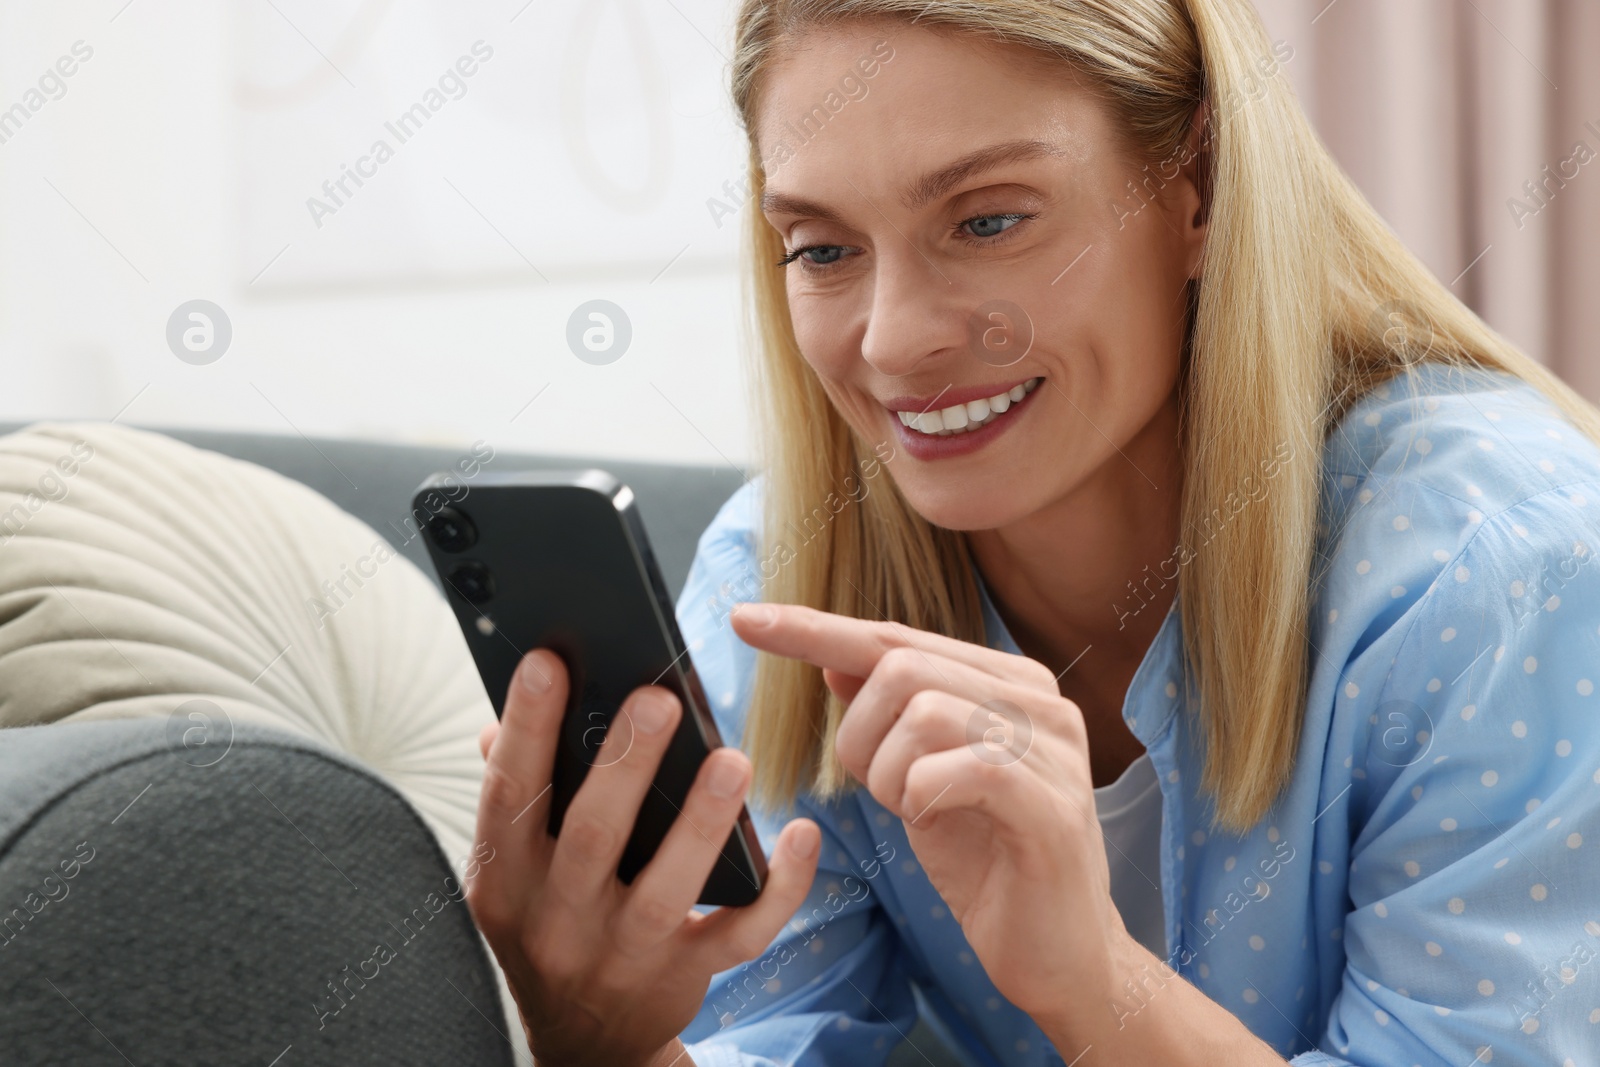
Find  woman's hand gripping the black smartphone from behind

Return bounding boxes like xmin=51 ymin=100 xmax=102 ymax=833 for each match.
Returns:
xmin=464 ymin=649 xmax=821 ymax=1067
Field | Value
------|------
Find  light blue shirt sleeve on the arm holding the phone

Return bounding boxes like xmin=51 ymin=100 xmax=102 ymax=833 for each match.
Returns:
xmin=677 ymin=482 xmax=917 ymax=1067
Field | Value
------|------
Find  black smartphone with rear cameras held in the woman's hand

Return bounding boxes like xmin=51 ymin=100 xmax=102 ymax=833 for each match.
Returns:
xmin=411 ymin=469 xmax=766 ymax=905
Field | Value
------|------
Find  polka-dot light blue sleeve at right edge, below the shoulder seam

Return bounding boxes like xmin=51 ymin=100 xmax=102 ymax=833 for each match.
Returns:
xmin=1290 ymin=486 xmax=1600 ymax=1067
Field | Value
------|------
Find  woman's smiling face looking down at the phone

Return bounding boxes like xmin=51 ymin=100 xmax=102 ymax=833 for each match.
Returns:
xmin=754 ymin=22 xmax=1205 ymax=530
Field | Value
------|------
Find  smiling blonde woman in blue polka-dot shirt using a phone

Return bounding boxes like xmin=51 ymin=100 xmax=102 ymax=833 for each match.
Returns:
xmin=469 ymin=0 xmax=1600 ymax=1067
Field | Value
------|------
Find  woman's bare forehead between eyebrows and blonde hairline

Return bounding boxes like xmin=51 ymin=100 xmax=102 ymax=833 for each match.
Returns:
xmin=752 ymin=21 xmax=1110 ymax=179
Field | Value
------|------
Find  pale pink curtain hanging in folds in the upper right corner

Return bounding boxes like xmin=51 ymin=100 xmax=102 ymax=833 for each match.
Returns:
xmin=1256 ymin=0 xmax=1600 ymax=402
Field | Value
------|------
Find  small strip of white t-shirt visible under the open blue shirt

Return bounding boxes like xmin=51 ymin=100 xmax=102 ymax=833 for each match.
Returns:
xmin=1094 ymin=752 xmax=1166 ymax=960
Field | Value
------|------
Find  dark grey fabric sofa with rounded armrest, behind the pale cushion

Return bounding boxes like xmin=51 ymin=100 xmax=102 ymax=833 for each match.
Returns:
xmin=0 ymin=426 xmax=957 ymax=1067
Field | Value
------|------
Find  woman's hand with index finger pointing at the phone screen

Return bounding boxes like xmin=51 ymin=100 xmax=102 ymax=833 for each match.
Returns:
xmin=731 ymin=603 xmax=1130 ymax=1029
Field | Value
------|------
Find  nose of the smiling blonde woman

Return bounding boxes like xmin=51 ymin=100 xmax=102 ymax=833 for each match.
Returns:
xmin=861 ymin=237 xmax=966 ymax=378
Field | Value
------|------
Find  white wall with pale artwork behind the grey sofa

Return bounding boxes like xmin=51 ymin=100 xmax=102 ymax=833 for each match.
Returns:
xmin=0 ymin=0 xmax=750 ymax=464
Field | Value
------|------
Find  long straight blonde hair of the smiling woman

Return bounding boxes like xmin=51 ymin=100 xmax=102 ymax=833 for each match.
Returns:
xmin=731 ymin=0 xmax=1600 ymax=833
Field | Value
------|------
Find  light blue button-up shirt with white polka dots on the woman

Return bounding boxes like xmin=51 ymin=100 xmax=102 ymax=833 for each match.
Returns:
xmin=677 ymin=365 xmax=1600 ymax=1067
